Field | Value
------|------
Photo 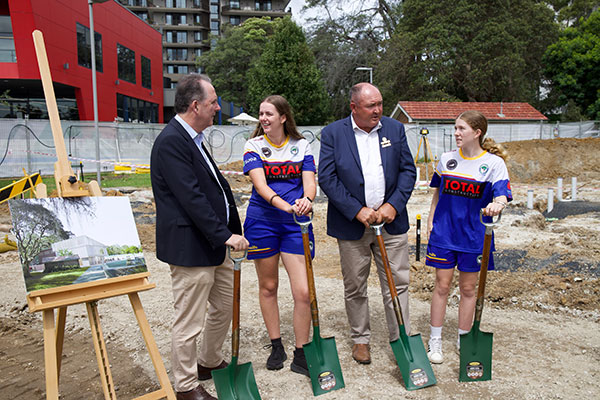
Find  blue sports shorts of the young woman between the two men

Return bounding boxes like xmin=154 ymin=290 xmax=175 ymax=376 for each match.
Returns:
xmin=244 ymin=217 xmax=315 ymax=260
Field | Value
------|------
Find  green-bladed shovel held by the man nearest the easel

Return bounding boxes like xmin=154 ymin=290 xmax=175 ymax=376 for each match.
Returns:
xmin=211 ymin=247 xmax=260 ymax=400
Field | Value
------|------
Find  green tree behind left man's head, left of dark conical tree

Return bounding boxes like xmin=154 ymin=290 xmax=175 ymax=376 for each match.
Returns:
xmin=196 ymin=17 xmax=273 ymax=109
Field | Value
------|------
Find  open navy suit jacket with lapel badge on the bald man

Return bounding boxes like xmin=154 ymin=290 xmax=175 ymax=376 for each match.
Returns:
xmin=318 ymin=117 xmax=417 ymax=240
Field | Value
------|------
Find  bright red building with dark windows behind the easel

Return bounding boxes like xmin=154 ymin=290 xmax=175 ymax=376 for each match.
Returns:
xmin=0 ymin=0 xmax=163 ymax=122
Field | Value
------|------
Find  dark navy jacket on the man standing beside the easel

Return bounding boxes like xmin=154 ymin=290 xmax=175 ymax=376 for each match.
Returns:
xmin=150 ymin=118 xmax=242 ymax=266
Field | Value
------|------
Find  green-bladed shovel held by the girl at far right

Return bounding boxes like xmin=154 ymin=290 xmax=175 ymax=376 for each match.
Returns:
xmin=458 ymin=209 xmax=500 ymax=382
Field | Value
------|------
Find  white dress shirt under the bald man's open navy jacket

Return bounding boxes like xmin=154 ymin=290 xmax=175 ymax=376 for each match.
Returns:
xmin=350 ymin=115 xmax=385 ymax=210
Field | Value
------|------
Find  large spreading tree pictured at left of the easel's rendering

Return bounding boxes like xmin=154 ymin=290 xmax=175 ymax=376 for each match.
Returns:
xmin=9 ymin=200 xmax=72 ymax=277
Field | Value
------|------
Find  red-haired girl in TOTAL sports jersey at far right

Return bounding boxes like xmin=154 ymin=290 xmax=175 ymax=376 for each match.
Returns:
xmin=426 ymin=111 xmax=512 ymax=364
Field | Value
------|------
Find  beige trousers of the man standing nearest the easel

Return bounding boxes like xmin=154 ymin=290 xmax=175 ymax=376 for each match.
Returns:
xmin=170 ymin=258 xmax=233 ymax=392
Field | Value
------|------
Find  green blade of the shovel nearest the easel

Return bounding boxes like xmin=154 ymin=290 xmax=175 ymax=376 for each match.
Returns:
xmin=211 ymin=362 xmax=260 ymax=400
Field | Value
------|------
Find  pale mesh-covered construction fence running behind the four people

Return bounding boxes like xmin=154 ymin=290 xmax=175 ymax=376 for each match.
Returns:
xmin=0 ymin=119 xmax=600 ymax=178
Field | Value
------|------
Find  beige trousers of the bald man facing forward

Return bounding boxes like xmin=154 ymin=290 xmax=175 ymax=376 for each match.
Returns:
xmin=338 ymin=228 xmax=410 ymax=344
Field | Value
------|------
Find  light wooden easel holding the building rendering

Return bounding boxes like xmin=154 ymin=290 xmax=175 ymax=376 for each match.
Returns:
xmin=27 ymin=30 xmax=175 ymax=400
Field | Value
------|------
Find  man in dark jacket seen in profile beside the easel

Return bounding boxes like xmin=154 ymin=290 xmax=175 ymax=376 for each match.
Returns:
xmin=150 ymin=74 xmax=248 ymax=400
